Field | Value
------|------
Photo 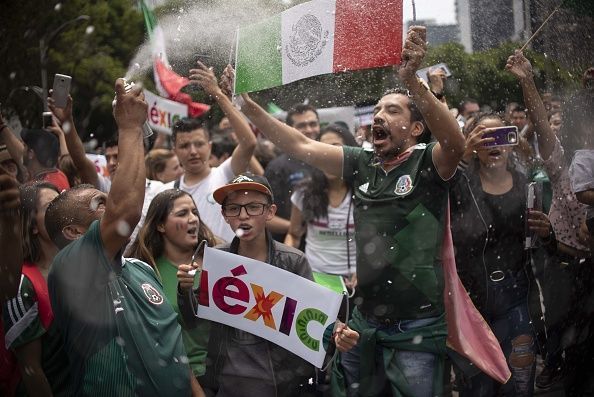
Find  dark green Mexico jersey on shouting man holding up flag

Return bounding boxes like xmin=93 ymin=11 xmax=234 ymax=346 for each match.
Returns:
xmin=343 ymin=143 xmax=448 ymax=320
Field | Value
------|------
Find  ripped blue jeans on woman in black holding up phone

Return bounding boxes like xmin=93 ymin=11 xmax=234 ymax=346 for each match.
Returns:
xmin=460 ymin=273 xmax=537 ymax=397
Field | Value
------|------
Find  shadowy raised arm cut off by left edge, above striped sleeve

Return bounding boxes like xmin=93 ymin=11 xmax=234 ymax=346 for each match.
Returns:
xmin=0 ymin=166 xmax=23 ymax=303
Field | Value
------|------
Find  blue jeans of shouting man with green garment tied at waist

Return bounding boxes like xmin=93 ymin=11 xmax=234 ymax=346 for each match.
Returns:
xmin=341 ymin=317 xmax=437 ymax=397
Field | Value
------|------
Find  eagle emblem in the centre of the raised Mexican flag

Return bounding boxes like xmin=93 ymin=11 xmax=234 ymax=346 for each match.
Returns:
xmin=285 ymin=14 xmax=329 ymax=66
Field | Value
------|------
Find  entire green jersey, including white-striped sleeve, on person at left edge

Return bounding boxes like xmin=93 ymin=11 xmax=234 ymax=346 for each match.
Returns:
xmin=2 ymin=275 xmax=70 ymax=396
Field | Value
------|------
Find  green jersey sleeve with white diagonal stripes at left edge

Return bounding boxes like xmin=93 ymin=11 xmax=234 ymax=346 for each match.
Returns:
xmin=2 ymin=275 xmax=46 ymax=350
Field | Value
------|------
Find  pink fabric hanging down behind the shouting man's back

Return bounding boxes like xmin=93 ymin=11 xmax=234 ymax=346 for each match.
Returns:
xmin=441 ymin=203 xmax=511 ymax=383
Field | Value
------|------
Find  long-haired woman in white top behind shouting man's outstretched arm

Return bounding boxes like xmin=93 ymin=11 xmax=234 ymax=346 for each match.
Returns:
xmin=285 ymin=124 xmax=357 ymax=289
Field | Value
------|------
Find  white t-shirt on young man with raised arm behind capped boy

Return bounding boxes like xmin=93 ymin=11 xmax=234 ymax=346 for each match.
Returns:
xmin=165 ymin=158 xmax=235 ymax=242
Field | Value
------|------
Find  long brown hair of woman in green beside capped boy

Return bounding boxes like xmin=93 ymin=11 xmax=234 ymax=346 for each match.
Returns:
xmin=130 ymin=189 xmax=217 ymax=273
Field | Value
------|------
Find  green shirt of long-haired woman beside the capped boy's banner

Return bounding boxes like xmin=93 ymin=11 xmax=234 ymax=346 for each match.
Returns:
xmin=157 ymin=256 xmax=210 ymax=376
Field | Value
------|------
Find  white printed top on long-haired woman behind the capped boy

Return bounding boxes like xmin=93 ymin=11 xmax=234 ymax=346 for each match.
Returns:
xmin=291 ymin=190 xmax=357 ymax=276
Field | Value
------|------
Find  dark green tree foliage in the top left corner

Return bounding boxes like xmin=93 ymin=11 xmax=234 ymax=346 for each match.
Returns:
xmin=0 ymin=0 xmax=144 ymax=142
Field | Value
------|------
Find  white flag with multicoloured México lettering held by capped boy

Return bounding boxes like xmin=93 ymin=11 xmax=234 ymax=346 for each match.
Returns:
xmin=197 ymin=248 xmax=342 ymax=368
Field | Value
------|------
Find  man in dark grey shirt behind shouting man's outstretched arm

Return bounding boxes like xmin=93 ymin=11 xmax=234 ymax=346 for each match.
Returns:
xmin=264 ymin=104 xmax=320 ymax=241
